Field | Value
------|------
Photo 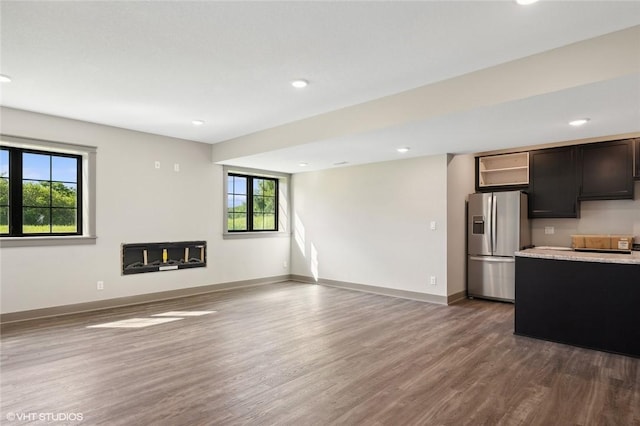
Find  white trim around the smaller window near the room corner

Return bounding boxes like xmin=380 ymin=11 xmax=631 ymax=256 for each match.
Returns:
xmin=222 ymin=166 xmax=291 ymax=240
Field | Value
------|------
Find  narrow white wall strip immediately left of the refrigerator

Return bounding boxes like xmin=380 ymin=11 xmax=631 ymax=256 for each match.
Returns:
xmin=447 ymin=155 xmax=475 ymax=296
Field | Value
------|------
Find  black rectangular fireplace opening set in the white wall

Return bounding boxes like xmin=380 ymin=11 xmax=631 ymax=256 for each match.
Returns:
xmin=122 ymin=241 xmax=207 ymax=275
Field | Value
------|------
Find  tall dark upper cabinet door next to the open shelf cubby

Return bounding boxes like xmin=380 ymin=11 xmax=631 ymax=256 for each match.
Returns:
xmin=529 ymin=146 xmax=578 ymax=218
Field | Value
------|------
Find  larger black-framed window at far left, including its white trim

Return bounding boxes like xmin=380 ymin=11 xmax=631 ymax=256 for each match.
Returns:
xmin=0 ymin=135 xmax=96 ymax=246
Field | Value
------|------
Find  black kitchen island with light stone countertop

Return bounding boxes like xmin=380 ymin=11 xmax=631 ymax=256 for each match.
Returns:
xmin=515 ymin=248 xmax=640 ymax=357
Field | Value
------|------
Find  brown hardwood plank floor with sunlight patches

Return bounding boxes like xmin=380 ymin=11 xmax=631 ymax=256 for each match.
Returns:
xmin=0 ymin=283 xmax=640 ymax=426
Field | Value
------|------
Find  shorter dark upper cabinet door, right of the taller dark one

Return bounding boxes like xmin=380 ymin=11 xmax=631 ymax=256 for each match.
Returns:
xmin=579 ymin=139 xmax=633 ymax=200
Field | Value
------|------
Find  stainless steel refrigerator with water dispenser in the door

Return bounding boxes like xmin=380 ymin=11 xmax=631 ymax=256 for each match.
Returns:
xmin=467 ymin=191 xmax=531 ymax=302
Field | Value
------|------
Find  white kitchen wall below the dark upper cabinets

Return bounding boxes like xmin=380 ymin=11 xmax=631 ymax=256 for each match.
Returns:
xmin=531 ymin=181 xmax=640 ymax=247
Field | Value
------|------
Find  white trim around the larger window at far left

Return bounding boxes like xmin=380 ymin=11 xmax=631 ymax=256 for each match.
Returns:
xmin=0 ymin=134 xmax=98 ymax=247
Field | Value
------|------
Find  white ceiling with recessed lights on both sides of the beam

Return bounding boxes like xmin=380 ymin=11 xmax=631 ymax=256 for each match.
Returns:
xmin=0 ymin=0 xmax=640 ymax=172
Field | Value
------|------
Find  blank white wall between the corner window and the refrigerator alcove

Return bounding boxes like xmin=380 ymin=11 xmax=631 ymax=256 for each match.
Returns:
xmin=291 ymin=155 xmax=447 ymax=296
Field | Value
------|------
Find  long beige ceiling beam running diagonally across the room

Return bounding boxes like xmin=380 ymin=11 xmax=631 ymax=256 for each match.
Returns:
xmin=212 ymin=25 xmax=640 ymax=162
